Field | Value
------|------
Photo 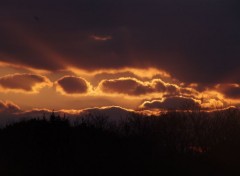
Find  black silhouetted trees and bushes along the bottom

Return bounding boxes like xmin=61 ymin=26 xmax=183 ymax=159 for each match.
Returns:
xmin=0 ymin=109 xmax=240 ymax=176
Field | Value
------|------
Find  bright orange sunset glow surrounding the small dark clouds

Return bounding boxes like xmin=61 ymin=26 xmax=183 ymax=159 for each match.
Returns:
xmin=0 ymin=59 xmax=240 ymax=115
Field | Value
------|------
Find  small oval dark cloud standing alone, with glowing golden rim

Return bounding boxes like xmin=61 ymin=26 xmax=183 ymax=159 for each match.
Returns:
xmin=56 ymin=76 xmax=92 ymax=95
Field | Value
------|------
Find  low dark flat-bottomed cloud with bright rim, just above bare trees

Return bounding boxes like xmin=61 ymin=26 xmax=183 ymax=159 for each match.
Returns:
xmin=140 ymin=97 xmax=200 ymax=110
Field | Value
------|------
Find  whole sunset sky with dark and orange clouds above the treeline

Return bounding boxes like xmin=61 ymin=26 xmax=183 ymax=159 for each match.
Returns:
xmin=0 ymin=0 xmax=240 ymax=118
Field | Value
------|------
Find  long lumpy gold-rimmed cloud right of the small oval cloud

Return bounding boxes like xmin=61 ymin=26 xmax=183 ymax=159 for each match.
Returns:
xmin=98 ymin=77 xmax=179 ymax=96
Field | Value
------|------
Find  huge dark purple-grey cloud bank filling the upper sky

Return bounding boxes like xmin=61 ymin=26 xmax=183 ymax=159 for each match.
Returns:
xmin=0 ymin=0 xmax=240 ymax=83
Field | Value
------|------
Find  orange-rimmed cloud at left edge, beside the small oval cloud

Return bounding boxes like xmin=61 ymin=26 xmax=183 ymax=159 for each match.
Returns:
xmin=0 ymin=73 xmax=51 ymax=93
